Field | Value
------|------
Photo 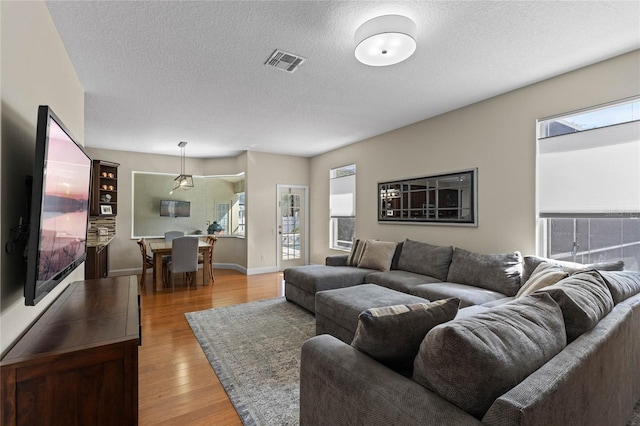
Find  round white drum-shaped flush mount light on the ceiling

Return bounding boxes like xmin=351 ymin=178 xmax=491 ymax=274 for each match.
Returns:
xmin=355 ymin=15 xmax=417 ymax=67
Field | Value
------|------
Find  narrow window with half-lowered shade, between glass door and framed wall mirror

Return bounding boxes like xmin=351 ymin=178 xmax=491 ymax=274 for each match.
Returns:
xmin=329 ymin=164 xmax=356 ymax=251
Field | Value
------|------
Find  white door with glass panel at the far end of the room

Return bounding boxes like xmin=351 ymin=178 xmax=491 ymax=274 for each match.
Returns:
xmin=277 ymin=185 xmax=308 ymax=271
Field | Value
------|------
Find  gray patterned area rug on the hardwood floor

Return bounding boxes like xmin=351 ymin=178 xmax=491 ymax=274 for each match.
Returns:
xmin=185 ymin=298 xmax=315 ymax=426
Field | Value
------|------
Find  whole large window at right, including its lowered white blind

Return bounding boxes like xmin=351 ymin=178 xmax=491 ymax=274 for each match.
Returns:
xmin=537 ymin=98 xmax=640 ymax=271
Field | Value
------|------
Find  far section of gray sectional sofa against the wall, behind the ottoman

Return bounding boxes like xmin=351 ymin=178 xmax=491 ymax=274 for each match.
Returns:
xmin=284 ymin=239 xmax=624 ymax=313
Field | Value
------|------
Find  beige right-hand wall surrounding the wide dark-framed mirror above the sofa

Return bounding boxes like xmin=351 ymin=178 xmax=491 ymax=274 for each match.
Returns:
xmin=310 ymin=51 xmax=640 ymax=263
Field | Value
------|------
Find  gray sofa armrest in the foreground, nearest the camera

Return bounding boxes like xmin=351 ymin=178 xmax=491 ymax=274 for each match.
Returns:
xmin=300 ymin=334 xmax=482 ymax=426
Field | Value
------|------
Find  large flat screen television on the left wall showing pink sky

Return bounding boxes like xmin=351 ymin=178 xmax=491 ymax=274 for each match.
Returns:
xmin=24 ymin=105 xmax=92 ymax=306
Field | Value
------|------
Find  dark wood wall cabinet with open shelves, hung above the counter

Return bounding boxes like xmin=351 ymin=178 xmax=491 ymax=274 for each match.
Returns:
xmin=90 ymin=160 xmax=120 ymax=216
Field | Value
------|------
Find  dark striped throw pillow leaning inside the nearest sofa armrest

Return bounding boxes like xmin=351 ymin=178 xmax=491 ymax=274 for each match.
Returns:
xmin=351 ymin=298 xmax=460 ymax=371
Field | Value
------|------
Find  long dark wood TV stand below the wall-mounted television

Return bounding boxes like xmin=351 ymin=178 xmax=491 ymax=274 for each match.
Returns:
xmin=0 ymin=276 xmax=141 ymax=425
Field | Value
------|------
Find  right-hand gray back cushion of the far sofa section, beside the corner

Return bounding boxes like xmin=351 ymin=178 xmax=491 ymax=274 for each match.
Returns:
xmin=447 ymin=248 xmax=522 ymax=296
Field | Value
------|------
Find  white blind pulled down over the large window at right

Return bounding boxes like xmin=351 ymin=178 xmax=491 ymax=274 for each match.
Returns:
xmin=537 ymin=121 xmax=640 ymax=217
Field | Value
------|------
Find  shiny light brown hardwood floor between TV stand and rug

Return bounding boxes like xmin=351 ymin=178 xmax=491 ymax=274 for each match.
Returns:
xmin=138 ymin=269 xmax=284 ymax=426
